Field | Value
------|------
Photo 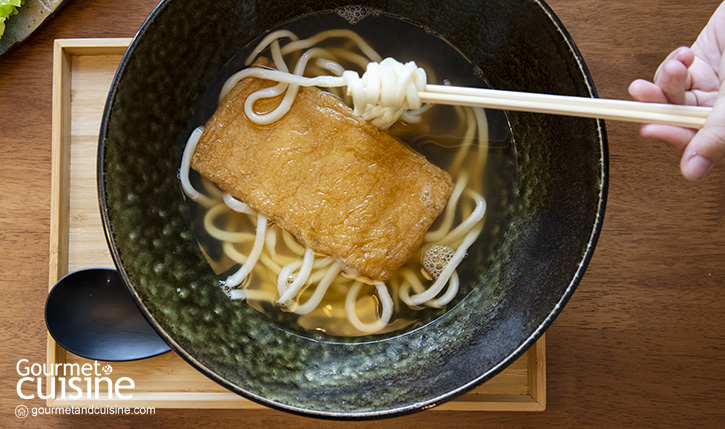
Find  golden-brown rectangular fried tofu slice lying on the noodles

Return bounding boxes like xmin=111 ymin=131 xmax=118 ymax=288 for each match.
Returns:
xmin=191 ymin=78 xmax=453 ymax=281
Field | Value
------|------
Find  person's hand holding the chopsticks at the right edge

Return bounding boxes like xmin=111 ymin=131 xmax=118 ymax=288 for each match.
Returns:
xmin=629 ymin=3 xmax=725 ymax=180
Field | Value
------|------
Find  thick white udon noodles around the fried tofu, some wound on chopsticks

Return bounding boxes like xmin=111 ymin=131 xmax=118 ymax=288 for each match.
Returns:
xmin=180 ymin=30 xmax=488 ymax=334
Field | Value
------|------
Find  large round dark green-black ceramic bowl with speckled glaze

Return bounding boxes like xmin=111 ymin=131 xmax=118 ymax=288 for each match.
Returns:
xmin=98 ymin=0 xmax=607 ymax=418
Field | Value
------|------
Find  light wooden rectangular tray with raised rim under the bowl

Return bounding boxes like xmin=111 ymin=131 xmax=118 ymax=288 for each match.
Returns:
xmin=47 ymin=39 xmax=546 ymax=411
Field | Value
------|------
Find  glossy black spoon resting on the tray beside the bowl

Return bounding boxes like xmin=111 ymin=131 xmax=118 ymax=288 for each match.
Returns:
xmin=45 ymin=268 xmax=170 ymax=362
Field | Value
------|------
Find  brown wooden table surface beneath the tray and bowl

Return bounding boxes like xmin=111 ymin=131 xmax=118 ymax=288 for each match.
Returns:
xmin=0 ymin=0 xmax=725 ymax=428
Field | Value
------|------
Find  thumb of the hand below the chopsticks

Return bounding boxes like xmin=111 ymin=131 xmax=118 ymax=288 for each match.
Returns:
xmin=680 ymin=93 xmax=725 ymax=180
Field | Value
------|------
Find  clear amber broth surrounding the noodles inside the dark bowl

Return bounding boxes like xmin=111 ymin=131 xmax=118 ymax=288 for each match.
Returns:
xmin=186 ymin=6 xmax=518 ymax=339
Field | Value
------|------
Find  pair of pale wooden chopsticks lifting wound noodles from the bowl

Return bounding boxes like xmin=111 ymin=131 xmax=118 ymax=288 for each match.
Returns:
xmin=418 ymin=85 xmax=712 ymax=129
